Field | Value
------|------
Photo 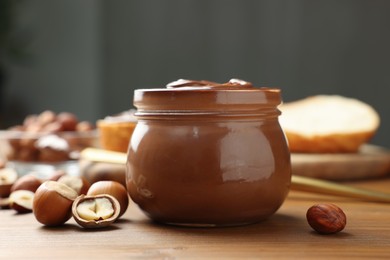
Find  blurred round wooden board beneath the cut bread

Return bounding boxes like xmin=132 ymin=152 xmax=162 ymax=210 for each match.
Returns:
xmin=291 ymin=145 xmax=390 ymax=181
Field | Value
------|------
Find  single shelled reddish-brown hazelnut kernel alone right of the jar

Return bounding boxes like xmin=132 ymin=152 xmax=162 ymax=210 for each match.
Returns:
xmin=306 ymin=203 xmax=347 ymax=234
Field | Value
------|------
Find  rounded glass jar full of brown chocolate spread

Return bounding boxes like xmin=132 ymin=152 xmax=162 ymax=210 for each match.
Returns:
xmin=126 ymin=79 xmax=291 ymax=226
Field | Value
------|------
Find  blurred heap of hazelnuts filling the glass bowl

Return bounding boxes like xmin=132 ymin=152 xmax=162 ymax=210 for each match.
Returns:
xmin=7 ymin=110 xmax=96 ymax=162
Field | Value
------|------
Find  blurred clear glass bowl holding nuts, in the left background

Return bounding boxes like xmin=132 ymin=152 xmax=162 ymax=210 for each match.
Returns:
xmin=0 ymin=130 xmax=98 ymax=175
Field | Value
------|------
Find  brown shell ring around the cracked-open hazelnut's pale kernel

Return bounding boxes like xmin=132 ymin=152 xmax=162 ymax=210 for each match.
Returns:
xmin=72 ymin=194 xmax=120 ymax=229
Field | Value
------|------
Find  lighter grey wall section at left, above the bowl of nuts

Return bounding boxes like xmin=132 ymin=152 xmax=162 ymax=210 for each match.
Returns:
xmin=5 ymin=0 xmax=102 ymax=123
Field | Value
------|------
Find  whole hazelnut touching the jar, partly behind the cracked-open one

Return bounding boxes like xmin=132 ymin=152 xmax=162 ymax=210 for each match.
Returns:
xmin=87 ymin=181 xmax=129 ymax=218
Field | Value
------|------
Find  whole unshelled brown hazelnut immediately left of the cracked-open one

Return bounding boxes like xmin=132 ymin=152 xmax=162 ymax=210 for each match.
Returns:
xmin=33 ymin=181 xmax=78 ymax=226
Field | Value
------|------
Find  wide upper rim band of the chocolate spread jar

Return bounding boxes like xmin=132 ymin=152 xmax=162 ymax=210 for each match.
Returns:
xmin=133 ymin=78 xmax=282 ymax=111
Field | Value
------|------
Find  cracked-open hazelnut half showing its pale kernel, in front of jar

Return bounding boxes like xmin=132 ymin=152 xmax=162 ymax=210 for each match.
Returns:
xmin=72 ymin=194 xmax=120 ymax=228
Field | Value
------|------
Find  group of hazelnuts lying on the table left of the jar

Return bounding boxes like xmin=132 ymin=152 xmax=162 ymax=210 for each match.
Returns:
xmin=0 ymin=168 xmax=129 ymax=228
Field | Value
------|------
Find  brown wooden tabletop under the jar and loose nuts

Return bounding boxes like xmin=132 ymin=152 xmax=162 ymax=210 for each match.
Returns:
xmin=0 ymin=178 xmax=390 ymax=259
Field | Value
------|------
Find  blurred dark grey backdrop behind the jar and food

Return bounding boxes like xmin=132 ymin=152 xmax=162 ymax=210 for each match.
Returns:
xmin=0 ymin=0 xmax=390 ymax=147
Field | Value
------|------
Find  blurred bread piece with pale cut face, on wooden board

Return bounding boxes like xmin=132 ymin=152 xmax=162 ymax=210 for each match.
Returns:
xmin=279 ymin=95 xmax=380 ymax=153
